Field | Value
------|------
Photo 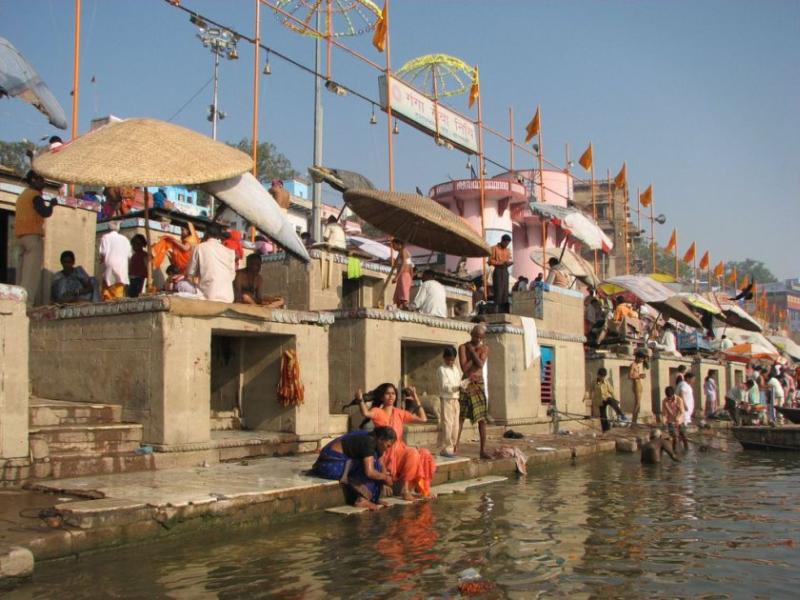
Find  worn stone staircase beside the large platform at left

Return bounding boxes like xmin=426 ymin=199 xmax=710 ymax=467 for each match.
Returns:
xmin=29 ymin=398 xmax=155 ymax=479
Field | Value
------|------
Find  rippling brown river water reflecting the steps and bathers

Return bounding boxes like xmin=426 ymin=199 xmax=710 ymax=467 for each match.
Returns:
xmin=8 ymin=436 xmax=800 ymax=599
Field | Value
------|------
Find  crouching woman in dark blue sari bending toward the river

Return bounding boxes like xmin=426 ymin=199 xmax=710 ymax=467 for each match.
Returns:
xmin=311 ymin=427 xmax=397 ymax=510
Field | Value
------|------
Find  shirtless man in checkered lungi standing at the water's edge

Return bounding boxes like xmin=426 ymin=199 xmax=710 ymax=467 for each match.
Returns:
xmin=458 ymin=324 xmax=491 ymax=458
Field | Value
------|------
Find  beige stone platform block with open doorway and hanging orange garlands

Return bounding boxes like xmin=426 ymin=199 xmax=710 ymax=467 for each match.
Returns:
xmin=31 ymin=296 xmax=342 ymax=445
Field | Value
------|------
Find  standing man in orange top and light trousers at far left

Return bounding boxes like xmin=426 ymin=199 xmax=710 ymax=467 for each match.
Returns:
xmin=14 ymin=171 xmax=53 ymax=306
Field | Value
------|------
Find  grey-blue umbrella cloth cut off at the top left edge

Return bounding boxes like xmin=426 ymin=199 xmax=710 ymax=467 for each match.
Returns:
xmin=0 ymin=37 xmax=67 ymax=129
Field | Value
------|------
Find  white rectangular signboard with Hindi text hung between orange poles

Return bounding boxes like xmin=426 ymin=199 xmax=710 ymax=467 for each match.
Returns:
xmin=378 ymin=75 xmax=478 ymax=154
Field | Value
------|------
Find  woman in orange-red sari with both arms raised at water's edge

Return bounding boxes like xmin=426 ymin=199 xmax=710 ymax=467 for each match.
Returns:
xmin=356 ymin=383 xmax=436 ymax=500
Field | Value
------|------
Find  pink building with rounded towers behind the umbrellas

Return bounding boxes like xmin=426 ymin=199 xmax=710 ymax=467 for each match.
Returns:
xmin=429 ymin=170 xmax=572 ymax=280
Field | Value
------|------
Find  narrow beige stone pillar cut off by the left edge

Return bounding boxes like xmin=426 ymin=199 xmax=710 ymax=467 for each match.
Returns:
xmin=0 ymin=284 xmax=28 ymax=459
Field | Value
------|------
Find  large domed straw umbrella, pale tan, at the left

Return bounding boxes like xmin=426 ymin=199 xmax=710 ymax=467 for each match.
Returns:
xmin=33 ymin=119 xmax=253 ymax=186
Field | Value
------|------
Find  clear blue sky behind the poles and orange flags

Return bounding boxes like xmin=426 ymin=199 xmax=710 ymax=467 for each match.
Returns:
xmin=0 ymin=0 xmax=800 ymax=278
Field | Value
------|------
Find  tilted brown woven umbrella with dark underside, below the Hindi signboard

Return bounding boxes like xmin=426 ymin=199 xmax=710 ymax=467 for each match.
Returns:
xmin=344 ymin=189 xmax=491 ymax=256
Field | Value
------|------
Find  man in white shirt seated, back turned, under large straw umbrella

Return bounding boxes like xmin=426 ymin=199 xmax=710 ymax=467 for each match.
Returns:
xmin=186 ymin=224 xmax=236 ymax=302
